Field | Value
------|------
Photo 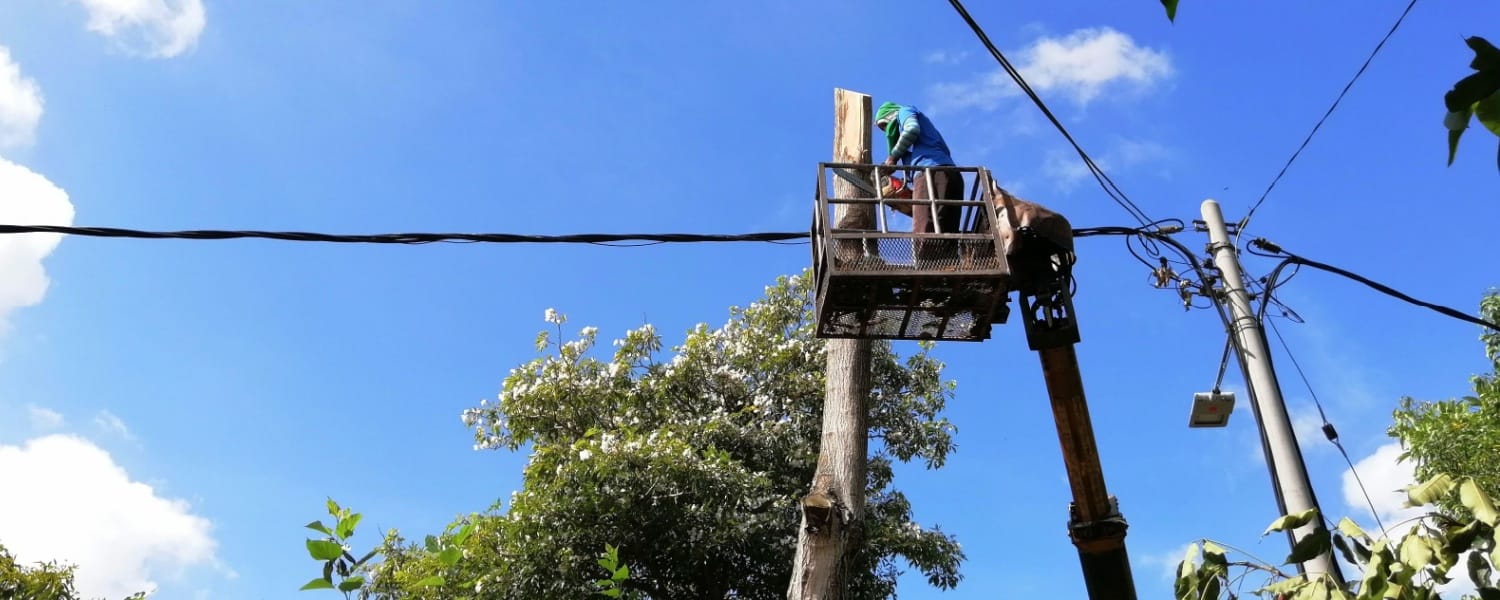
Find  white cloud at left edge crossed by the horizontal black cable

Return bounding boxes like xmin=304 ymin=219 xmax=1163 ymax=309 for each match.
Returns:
xmin=0 ymin=158 xmax=74 ymax=332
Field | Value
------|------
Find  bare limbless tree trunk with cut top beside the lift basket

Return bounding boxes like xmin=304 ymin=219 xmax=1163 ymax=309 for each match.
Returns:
xmin=786 ymin=90 xmax=875 ymax=600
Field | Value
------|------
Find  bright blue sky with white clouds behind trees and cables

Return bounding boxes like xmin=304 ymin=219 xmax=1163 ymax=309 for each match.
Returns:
xmin=0 ymin=0 xmax=1500 ymax=599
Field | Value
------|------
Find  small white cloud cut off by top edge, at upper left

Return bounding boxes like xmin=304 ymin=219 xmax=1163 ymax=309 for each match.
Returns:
xmin=75 ymin=0 xmax=207 ymax=59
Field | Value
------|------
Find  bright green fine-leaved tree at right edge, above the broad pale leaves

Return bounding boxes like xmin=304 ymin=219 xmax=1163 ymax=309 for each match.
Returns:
xmin=1388 ymin=293 xmax=1500 ymax=525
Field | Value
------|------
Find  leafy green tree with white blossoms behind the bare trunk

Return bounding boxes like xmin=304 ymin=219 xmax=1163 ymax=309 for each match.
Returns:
xmin=368 ymin=275 xmax=963 ymax=600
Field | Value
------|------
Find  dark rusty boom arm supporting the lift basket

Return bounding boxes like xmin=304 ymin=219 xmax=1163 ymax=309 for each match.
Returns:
xmin=1010 ymin=230 xmax=1136 ymax=600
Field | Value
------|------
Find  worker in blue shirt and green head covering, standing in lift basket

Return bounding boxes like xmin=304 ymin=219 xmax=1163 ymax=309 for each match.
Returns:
xmin=875 ymin=102 xmax=965 ymax=269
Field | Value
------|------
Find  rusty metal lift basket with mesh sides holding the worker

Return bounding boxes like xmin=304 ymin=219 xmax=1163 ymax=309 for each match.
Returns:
xmin=812 ymin=162 xmax=1011 ymax=342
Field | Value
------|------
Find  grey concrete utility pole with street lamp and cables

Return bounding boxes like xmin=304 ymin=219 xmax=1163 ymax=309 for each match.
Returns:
xmin=1203 ymin=200 xmax=1344 ymax=587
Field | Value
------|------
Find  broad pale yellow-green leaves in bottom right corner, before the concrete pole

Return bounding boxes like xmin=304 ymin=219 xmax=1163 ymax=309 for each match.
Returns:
xmin=1175 ymin=474 xmax=1500 ymax=600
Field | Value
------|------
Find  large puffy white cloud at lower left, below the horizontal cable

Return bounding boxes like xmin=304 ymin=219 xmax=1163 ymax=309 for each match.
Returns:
xmin=0 ymin=435 xmax=216 ymax=599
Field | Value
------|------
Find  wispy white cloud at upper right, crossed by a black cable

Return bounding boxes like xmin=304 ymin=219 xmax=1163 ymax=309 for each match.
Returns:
xmin=929 ymin=27 xmax=1173 ymax=113
